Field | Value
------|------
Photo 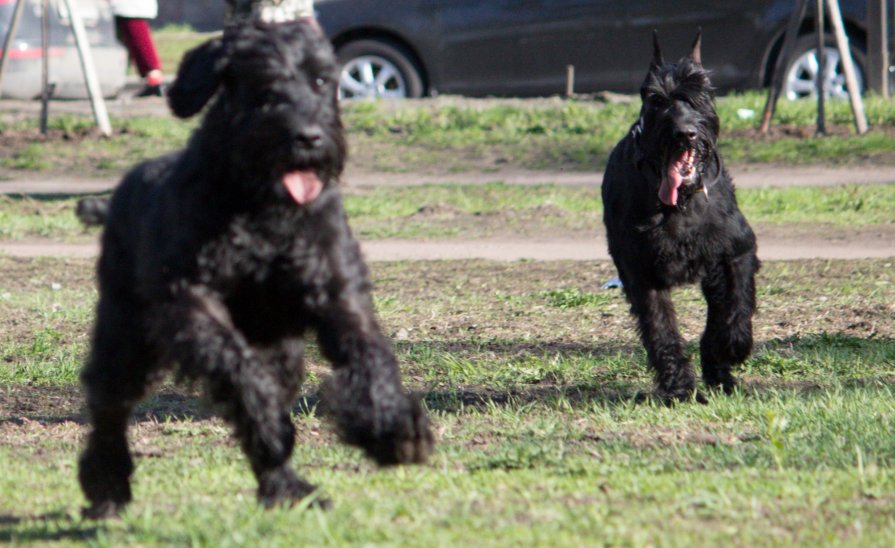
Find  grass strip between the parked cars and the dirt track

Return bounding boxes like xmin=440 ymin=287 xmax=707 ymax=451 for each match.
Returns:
xmin=0 ymin=92 xmax=895 ymax=177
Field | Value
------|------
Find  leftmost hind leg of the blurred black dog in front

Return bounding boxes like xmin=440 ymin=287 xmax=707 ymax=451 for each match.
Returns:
xmin=78 ymin=293 xmax=157 ymax=519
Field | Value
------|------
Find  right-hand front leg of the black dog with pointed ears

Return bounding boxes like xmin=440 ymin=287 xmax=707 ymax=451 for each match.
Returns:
xmin=699 ymin=251 xmax=759 ymax=394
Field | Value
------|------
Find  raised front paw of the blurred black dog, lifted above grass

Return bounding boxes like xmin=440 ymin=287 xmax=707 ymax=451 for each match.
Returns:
xmin=365 ymin=398 xmax=435 ymax=466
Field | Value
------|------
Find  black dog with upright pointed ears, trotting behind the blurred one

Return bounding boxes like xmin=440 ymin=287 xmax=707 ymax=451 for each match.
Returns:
xmin=602 ymin=36 xmax=759 ymax=401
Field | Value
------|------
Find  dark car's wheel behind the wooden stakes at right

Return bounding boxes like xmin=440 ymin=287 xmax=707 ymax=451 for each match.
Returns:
xmin=782 ymin=35 xmax=866 ymax=99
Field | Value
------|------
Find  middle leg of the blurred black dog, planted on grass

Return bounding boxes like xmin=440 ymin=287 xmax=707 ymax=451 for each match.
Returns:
xmin=156 ymin=287 xmax=326 ymax=507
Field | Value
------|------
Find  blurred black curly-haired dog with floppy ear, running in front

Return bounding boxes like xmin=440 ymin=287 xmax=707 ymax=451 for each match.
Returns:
xmin=78 ymin=23 xmax=433 ymax=517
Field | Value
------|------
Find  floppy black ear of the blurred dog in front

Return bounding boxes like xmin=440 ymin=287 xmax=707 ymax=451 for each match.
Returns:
xmin=168 ymin=39 xmax=228 ymax=118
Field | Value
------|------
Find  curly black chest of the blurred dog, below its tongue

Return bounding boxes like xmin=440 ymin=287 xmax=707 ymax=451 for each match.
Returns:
xmin=177 ymin=191 xmax=368 ymax=340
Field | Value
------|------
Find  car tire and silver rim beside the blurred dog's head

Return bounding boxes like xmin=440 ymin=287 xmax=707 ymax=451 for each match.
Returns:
xmin=337 ymin=40 xmax=425 ymax=99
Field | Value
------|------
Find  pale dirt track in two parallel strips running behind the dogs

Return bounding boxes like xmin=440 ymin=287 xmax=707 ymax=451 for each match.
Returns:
xmin=0 ymin=166 xmax=895 ymax=261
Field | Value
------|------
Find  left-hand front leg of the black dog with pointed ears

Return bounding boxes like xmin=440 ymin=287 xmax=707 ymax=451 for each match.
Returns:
xmin=624 ymin=282 xmax=703 ymax=402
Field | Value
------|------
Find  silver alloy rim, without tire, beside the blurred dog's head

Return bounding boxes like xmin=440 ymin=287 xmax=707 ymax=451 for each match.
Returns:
xmin=339 ymin=55 xmax=407 ymax=99
